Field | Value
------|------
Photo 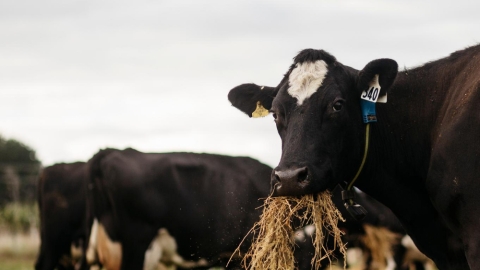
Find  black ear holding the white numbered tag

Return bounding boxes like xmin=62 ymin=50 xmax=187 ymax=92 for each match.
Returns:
xmin=357 ymin=58 xmax=398 ymax=95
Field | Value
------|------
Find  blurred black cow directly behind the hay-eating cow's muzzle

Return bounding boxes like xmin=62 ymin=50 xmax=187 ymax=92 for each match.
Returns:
xmin=89 ymin=149 xmax=272 ymax=270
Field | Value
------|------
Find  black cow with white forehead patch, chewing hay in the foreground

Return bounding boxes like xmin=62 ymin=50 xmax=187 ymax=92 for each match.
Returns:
xmin=229 ymin=45 xmax=480 ymax=269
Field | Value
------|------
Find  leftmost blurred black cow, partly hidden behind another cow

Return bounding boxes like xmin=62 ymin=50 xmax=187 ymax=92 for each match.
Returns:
xmin=35 ymin=162 xmax=91 ymax=270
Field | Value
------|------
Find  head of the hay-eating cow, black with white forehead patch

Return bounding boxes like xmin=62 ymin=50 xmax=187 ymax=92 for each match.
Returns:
xmin=228 ymin=49 xmax=398 ymax=196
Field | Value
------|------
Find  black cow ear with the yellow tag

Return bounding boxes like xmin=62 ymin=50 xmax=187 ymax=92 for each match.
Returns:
xmin=228 ymin=83 xmax=277 ymax=118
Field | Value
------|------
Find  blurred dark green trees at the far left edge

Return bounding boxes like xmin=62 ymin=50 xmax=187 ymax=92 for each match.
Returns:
xmin=0 ymin=136 xmax=41 ymax=206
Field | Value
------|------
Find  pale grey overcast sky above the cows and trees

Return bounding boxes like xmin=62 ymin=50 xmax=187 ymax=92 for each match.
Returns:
xmin=0 ymin=0 xmax=480 ymax=166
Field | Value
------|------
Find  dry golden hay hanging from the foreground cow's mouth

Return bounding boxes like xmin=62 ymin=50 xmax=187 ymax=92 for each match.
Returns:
xmin=232 ymin=192 xmax=346 ymax=270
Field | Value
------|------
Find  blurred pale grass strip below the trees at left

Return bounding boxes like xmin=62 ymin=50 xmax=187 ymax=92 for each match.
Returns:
xmin=0 ymin=230 xmax=40 ymax=270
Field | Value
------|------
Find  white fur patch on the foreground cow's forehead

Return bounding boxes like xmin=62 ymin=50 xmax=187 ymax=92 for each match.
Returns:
xmin=288 ymin=60 xmax=328 ymax=105
